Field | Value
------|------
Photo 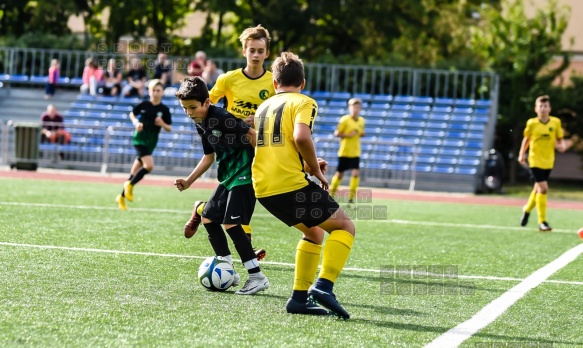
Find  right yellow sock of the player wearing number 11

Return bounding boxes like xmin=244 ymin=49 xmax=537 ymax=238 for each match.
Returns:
xmin=318 ymin=230 xmax=354 ymax=283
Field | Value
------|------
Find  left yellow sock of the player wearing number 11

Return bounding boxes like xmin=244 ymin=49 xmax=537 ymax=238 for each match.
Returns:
xmin=294 ymin=239 xmax=322 ymax=291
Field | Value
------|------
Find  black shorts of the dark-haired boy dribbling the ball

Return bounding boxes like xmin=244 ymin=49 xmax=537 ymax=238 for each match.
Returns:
xmin=202 ymin=184 xmax=256 ymax=225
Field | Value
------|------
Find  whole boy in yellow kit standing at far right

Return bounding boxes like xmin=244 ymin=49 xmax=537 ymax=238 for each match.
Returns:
xmin=518 ymin=95 xmax=565 ymax=232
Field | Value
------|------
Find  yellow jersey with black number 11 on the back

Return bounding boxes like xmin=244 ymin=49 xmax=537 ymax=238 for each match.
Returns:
xmin=251 ymin=92 xmax=318 ymax=198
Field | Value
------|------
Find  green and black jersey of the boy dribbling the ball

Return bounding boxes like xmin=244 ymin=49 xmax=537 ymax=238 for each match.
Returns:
xmin=196 ymin=105 xmax=255 ymax=190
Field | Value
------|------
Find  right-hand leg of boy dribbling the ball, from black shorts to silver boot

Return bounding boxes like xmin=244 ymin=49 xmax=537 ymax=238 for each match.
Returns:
xmin=223 ymin=184 xmax=269 ymax=295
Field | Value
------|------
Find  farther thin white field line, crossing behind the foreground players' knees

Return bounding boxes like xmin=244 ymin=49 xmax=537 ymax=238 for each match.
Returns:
xmin=0 ymin=202 xmax=575 ymax=234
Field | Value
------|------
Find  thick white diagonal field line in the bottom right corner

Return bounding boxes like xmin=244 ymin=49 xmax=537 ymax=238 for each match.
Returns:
xmin=425 ymin=244 xmax=583 ymax=348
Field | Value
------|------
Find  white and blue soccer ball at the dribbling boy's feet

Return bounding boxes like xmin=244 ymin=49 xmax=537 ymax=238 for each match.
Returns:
xmin=198 ymin=256 xmax=235 ymax=291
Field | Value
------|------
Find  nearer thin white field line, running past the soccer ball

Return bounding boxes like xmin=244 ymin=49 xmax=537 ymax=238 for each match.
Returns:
xmin=0 ymin=242 xmax=583 ymax=285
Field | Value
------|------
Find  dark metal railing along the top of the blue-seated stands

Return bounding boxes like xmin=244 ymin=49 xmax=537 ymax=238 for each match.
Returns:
xmin=0 ymin=47 xmax=498 ymax=101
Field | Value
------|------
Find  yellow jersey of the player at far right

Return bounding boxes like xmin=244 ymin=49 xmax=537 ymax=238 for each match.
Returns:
xmin=524 ymin=116 xmax=563 ymax=169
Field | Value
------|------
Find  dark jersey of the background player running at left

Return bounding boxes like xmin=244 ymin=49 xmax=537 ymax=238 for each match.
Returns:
xmin=132 ymin=101 xmax=172 ymax=152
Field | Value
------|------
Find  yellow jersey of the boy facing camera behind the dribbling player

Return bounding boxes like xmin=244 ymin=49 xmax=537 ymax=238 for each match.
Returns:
xmin=209 ymin=69 xmax=275 ymax=119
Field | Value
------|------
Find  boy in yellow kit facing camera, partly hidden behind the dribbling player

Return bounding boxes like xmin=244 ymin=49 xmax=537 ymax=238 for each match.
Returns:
xmin=184 ymin=25 xmax=275 ymax=260
